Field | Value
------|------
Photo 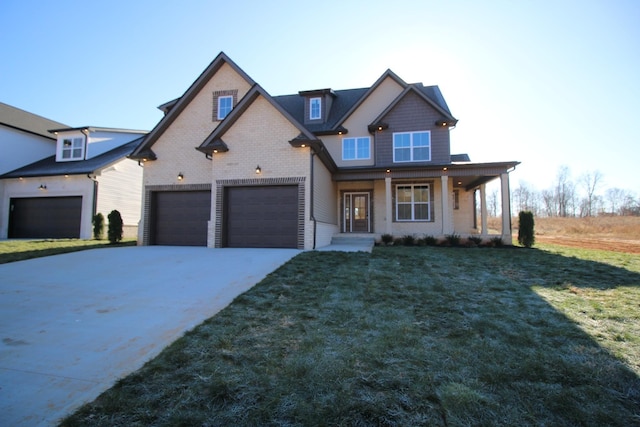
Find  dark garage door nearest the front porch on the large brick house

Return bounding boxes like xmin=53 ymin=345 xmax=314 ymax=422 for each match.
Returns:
xmin=225 ymin=185 xmax=298 ymax=248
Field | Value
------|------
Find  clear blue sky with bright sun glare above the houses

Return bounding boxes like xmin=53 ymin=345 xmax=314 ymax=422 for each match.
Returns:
xmin=0 ymin=0 xmax=640 ymax=195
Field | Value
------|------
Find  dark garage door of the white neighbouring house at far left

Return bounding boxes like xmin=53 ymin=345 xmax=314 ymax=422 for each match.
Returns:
xmin=9 ymin=196 xmax=82 ymax=239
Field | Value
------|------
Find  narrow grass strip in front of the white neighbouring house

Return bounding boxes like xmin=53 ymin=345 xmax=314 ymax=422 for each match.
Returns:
xmin=0 ymin=239 xmax=136 ymax=264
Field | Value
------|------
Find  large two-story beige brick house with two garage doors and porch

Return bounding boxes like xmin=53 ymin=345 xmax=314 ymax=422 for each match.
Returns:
xmin=131 ymin=53 xmax=519 ymax=249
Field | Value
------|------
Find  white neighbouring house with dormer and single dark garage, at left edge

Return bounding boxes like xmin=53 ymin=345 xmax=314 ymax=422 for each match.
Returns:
xmin=0 ymin=116 xmax=146 ymax=239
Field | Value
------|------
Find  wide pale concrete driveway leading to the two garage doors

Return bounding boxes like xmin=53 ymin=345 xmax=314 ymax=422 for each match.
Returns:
xmin=0 ymin=246 xmax=300 ymax=426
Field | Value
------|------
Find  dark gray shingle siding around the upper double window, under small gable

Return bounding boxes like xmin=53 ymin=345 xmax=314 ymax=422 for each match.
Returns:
xmin=374 ymin=92 xmax=451 ymax=167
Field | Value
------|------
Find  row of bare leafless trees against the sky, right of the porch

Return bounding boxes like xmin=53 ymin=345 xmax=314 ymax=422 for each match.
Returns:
xmin=487 ymin=166 xmax=640 ymax=217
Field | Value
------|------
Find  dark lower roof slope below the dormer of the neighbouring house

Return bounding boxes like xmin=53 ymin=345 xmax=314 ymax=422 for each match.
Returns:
xmin=0 ymin=137 xmax=143 ymax=179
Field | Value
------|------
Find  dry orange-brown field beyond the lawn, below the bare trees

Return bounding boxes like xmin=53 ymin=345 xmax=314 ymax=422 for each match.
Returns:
xmin=488 ymin=216 xmax=640 ymax=253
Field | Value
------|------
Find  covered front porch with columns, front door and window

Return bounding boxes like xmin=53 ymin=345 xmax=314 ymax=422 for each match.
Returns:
xmin=334 ymin=162 xmax=518 ymax=245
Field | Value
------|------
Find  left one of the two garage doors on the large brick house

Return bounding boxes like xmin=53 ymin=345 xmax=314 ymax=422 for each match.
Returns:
xmin=150 ymin=190 xmax=211 ymax=246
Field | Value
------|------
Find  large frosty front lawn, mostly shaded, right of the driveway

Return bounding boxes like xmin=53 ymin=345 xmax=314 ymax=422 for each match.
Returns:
xmin=63 ymin=246 xmax=640 ymax=426
